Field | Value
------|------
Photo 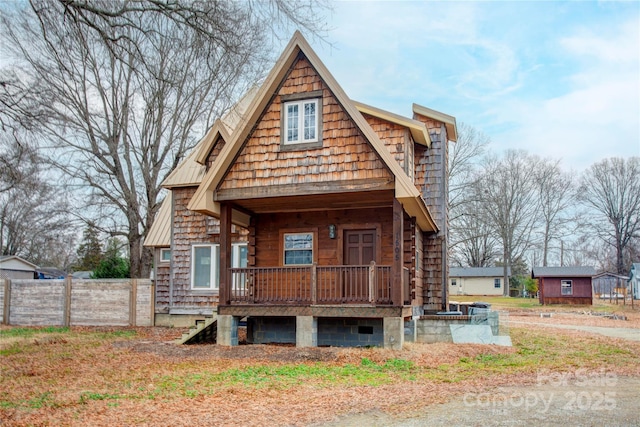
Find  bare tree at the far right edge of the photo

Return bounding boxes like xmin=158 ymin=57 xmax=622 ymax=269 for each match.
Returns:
xmin=578 ymin=157 xmax=640 ymax=274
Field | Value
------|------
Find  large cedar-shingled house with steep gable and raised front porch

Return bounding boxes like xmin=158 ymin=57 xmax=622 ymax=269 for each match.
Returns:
xmin=145 ymin=32 xmax=457 ymax=348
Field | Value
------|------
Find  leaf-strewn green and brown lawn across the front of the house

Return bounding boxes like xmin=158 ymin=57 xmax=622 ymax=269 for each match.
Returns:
xmin=0 ymin=327 xmax=640 ymax=418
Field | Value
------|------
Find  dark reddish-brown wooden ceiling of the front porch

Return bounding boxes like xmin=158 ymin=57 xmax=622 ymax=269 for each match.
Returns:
xmin=225 ymin=190 xmax=394 ymax=214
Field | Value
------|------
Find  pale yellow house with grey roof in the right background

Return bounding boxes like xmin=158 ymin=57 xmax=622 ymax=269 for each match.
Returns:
xmin=449 ymin=267 xmax=511 ymax=295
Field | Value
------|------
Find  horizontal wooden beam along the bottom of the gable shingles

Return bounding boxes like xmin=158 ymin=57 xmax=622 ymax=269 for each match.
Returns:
xmin=213 ymin=178 xmax=395 ymax=202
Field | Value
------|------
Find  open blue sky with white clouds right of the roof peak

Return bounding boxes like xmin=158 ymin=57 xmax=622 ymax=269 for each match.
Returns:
xmin=309 ymin=1 xmax=640 ymax=172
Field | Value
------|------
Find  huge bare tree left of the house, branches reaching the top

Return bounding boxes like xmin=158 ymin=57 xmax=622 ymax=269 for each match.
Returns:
xmin=2 ymin=0 xmax=336 ymax=277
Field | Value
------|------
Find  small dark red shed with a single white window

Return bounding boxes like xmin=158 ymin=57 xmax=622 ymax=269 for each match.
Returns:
xmin=531 ymin=267 xmax=596 ymax=305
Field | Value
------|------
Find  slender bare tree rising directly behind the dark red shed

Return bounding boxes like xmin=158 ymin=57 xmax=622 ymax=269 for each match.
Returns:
xmin=535 ymin=160 xmax=575 ymax=267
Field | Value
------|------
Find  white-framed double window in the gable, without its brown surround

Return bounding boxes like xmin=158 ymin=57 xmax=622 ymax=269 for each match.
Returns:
xmin=283 ymin=98 xmax=320 ymax=145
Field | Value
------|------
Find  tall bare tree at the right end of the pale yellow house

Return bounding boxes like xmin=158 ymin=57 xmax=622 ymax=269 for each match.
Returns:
xmin=479 ymin=150 xmax=539 ymax=295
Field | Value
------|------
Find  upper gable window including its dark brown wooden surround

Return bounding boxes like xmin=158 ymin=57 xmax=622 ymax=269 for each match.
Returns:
xmin=282 ymin=92 xmax=322 ymax=148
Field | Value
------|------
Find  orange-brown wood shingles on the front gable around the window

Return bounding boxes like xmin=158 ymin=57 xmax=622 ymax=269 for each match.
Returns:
xmin=218 ymin=58 xmax=393 ymax=196
